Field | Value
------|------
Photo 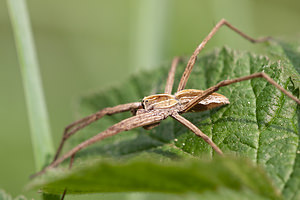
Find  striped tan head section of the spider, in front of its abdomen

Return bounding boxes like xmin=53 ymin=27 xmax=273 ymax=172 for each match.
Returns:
xmin=142 ymin=94 xmax=178 ymax=110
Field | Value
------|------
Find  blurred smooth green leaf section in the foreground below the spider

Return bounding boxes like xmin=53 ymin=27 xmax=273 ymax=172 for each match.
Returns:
xmin=29 ymin=157 xmax=279 ymax=199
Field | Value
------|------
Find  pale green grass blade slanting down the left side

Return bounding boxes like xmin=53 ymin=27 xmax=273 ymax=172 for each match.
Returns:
xmin=7 ymin=0 xmax=54 ymax=171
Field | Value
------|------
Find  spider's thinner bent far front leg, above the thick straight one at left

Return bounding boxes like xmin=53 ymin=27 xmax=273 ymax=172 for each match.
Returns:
xmin=53 ymin=102 xmax=142 ymax=162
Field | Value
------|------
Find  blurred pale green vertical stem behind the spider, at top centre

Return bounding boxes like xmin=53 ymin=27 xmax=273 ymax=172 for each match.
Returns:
xmin=132 ymin=0 xmax=170 ymax=69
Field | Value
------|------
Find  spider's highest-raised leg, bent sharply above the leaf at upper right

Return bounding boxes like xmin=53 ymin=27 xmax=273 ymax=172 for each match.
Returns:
xmin=177 ymin=19 xmax=271 ymax=92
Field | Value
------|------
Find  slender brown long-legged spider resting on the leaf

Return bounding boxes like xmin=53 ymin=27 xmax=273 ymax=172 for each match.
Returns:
xmin=35 ymin=19 xmax=300 ymax=178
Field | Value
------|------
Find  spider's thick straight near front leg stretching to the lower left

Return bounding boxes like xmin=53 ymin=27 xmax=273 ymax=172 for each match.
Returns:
xmin=32 ymin=110 xmax=171 ymax=177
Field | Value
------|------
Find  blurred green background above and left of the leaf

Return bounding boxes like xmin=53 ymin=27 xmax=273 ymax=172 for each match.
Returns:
xmin=0 ymin=0 xmax=300 ymax=197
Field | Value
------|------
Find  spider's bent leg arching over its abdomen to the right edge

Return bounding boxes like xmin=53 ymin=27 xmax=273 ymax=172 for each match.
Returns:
xmin=180 ymin=72 xmax=300 ymax=112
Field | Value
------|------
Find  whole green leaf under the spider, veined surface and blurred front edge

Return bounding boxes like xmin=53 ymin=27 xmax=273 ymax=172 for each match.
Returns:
xmin=30 ymin=44 xmax=300 ymax=198
